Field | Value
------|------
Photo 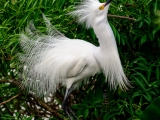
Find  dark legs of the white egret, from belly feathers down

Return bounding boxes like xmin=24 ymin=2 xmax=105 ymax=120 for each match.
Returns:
xmin=62 ymin=87 xmax=77 ymax=120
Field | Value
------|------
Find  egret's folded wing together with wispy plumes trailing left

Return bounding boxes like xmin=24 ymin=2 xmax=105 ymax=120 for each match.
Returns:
xmin=20 ymin=36 xmax=96 ymax=94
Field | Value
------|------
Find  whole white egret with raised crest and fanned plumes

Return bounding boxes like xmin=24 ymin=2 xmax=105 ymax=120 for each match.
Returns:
xmin=19 ymin=0 xmax=130 ymax=119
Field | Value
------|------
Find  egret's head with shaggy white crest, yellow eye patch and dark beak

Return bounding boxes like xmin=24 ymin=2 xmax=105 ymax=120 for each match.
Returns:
xmin=71 ymin=0 xmax=112 ymax=28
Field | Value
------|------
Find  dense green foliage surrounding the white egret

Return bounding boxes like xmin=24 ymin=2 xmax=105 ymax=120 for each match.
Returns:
xmin=0 ymin=0 xmax=160 ymax=120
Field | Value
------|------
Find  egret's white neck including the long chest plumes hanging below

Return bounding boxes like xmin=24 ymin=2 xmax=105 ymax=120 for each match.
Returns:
xmin=94 ymin=21 xmax=127 ymax=89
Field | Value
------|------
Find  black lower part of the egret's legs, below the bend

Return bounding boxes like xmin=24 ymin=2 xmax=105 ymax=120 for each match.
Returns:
xmin=62 ymin=102 xmax=77 ymax=120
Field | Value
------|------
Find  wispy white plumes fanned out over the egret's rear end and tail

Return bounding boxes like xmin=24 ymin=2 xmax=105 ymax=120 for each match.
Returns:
xmin=18 ymin=15 xmax=68 ymax=96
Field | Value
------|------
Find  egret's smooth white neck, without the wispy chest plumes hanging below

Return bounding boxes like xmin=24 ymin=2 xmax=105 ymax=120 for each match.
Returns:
xmin=94 ymin=19 xmax=122 ymax=71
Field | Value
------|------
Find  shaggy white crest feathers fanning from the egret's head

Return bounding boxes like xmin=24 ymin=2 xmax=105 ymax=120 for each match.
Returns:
xmin=70 ymin=0 xmax=108 ymax=28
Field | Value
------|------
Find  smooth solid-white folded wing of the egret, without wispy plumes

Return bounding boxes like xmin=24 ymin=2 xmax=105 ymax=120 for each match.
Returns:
xmin=35 ymin=40 xmax=95 ymax=79
